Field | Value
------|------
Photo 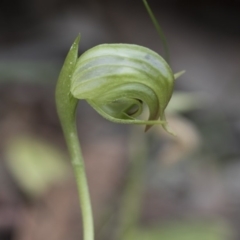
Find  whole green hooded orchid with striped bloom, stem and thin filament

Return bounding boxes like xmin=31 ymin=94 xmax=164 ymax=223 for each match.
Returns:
xmin=56 ymin=0 xmax=183 ymax=240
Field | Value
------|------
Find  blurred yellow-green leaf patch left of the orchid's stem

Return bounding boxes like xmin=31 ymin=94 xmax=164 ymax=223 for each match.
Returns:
xmin=5 ymin=136 xmax=68 ymax=197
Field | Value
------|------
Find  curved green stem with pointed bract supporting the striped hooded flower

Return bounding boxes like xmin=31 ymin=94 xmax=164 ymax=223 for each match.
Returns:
xmin=56 ymin=36 xmax=94 ymax=240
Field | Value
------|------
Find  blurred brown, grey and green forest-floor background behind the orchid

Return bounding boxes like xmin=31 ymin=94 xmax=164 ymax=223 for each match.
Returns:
xmin=0 ymin=0 xmax=240 ymax=240
